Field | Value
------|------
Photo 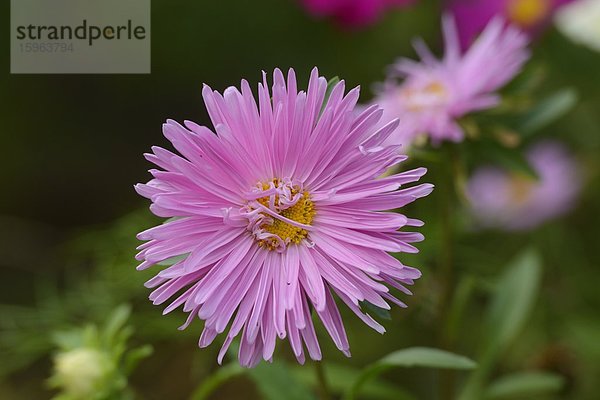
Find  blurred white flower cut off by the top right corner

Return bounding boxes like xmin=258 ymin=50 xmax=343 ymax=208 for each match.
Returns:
xmin=556 ymin=0 xmax=600 ymax=51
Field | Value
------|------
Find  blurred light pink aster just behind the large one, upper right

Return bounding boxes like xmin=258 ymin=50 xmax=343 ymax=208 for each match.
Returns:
xmin=373 ymin=16 xmax=529 ymax=145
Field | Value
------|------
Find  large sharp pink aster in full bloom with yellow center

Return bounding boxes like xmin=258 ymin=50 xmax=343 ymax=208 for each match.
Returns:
xmin=136 ymin=68 xmax=432 ymax=366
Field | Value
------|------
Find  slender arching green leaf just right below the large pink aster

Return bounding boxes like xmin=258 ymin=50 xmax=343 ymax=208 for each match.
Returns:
xmin=346 ymin=347 xmax=477 ymax=399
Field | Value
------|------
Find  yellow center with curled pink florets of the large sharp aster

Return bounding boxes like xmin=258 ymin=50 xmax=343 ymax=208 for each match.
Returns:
xmin=245 ymin=178 xmax=315 ymax=251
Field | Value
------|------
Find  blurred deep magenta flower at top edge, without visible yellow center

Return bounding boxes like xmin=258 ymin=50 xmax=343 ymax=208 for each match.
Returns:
xmin=301 ymin=0 xmax=415 ymax=27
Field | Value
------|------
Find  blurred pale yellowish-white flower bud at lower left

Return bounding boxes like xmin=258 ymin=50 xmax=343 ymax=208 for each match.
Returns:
xmin=52 ymin=347 xmax=111 ymax=399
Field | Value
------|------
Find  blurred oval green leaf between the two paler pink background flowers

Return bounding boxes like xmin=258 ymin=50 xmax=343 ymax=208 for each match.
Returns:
xmin=517 ymin=88 xmax=577 ymax=136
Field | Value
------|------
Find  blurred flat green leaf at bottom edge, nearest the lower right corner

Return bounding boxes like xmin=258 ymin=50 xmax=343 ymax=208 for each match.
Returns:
xmin=485 ymin=372 xmax=565 ymax=400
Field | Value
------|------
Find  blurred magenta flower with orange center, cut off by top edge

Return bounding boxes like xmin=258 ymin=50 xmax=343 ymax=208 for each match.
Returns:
xmin=447 ymin=0 xmax=573 ymax=48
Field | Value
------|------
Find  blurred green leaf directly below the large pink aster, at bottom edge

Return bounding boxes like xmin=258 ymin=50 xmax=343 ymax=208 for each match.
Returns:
xmin=248 ymin=362 xmax=315 ymax=400
